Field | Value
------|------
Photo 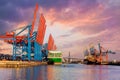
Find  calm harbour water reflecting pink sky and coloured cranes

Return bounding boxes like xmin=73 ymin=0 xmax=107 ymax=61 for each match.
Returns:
xmin=0 ymin=64 xmax=120 ymax=80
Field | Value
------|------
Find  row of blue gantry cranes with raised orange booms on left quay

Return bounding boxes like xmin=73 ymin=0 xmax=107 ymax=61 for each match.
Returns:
xmin=0 ymin=4 xmax=56 ymax=61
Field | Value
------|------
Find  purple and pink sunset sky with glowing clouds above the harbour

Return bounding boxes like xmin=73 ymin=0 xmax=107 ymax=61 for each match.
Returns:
xmin=0 ymin=0 xmax=120 ymax=59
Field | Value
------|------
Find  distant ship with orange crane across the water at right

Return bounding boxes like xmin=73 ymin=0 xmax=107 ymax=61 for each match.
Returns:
xmin=83 ymin=43 xmax=115 ymax=64
